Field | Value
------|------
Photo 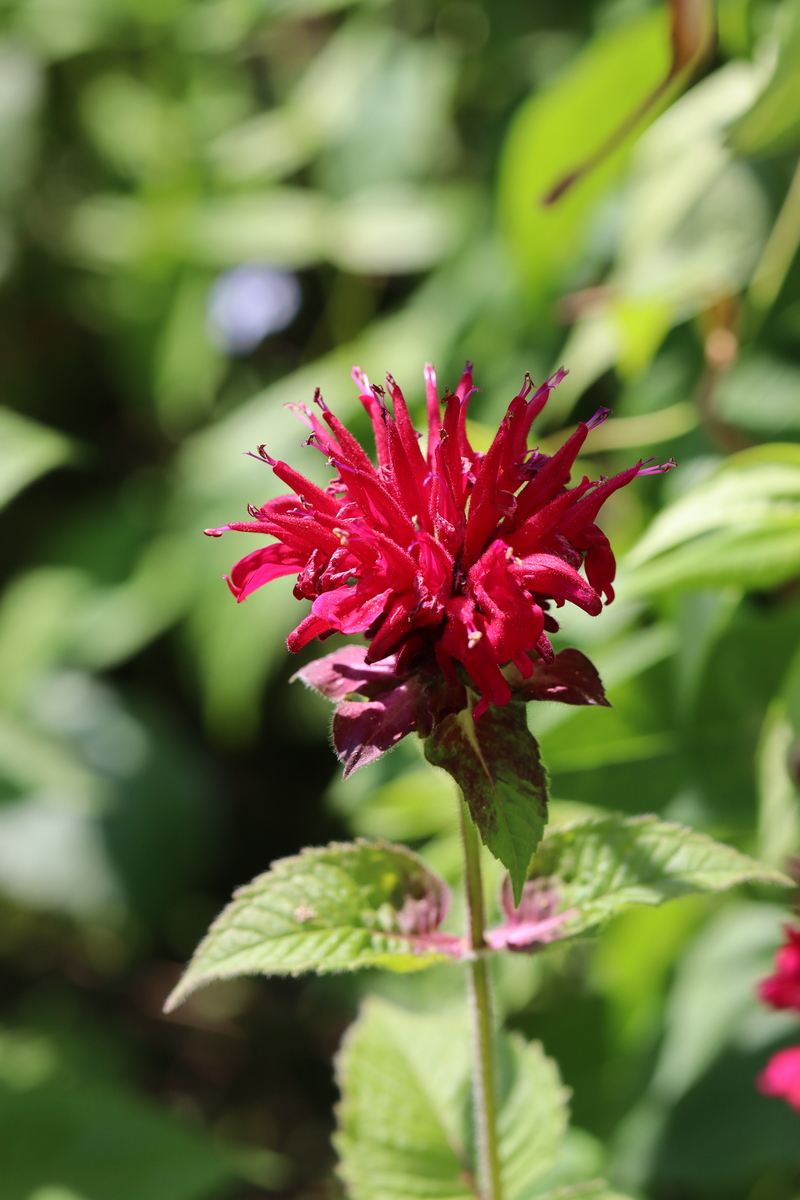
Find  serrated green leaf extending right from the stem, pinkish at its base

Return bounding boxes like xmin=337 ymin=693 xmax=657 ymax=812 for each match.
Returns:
xmin=517 ymin=814 xmax=793 ymax=942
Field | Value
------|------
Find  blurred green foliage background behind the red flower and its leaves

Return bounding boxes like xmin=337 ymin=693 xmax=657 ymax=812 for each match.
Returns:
xmin=0 ymin=0 xmax=800 ymax=1200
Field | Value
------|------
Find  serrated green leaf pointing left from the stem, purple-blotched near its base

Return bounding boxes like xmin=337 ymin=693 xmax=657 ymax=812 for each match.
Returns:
xmin=166 ymin=841 xmax=447 ymax=1012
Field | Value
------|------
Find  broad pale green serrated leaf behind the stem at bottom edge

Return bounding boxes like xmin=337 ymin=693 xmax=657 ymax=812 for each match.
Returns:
xmin=335 ymin=997 xmax=567 ymax=1200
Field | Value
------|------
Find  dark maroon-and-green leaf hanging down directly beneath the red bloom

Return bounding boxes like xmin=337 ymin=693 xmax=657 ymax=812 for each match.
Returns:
xmin=425 ymin=704 xmax=547 ymax=900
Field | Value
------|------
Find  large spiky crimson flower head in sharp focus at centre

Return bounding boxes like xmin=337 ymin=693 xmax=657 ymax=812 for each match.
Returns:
xmin=206 ymin=362 xmax=673 ymax=719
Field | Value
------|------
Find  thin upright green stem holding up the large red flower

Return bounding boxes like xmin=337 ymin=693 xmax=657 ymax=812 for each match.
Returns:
xmin=461 ymin=803 xmax=503 ymax=1200
